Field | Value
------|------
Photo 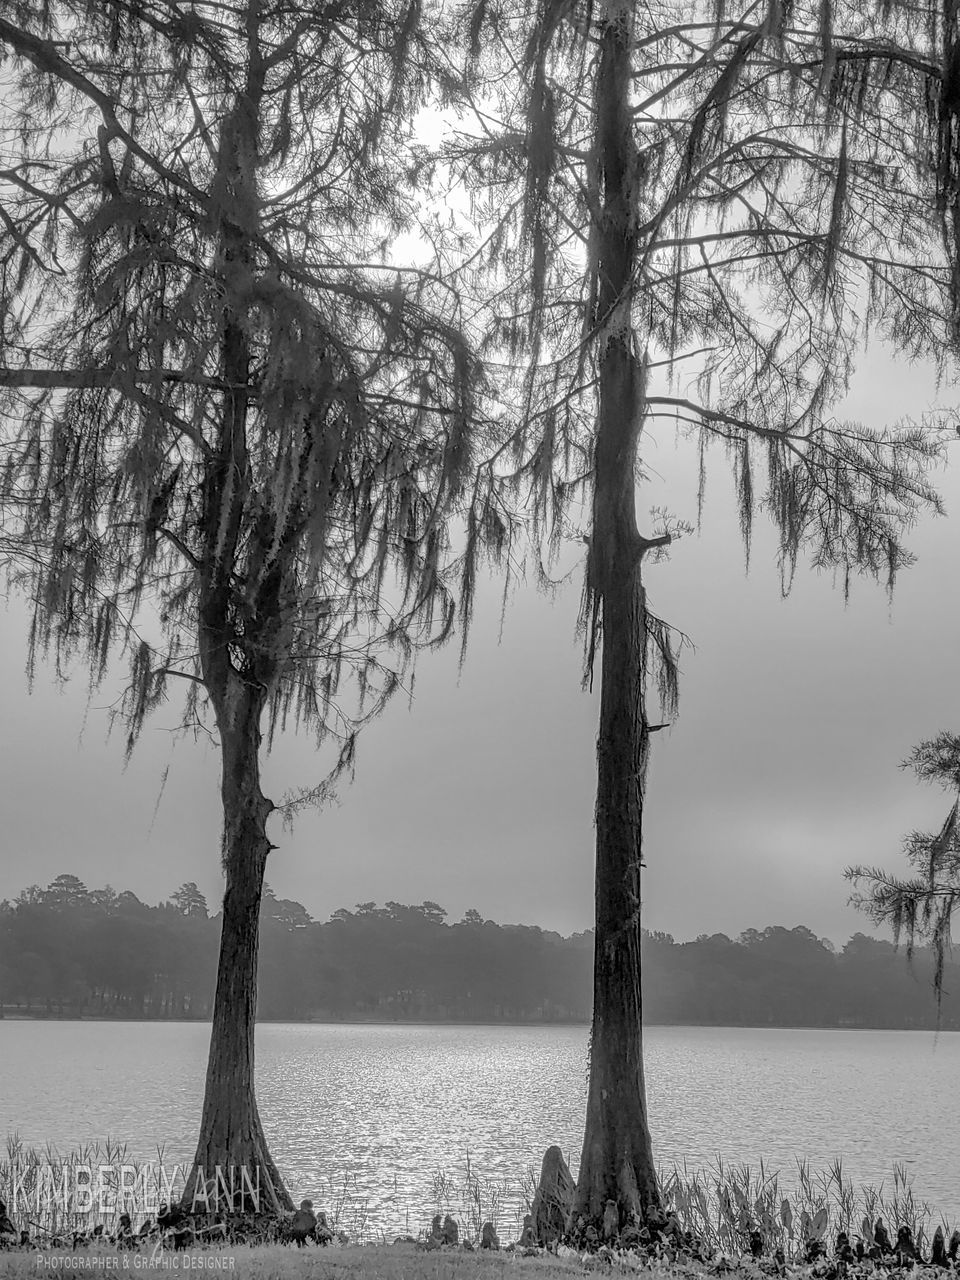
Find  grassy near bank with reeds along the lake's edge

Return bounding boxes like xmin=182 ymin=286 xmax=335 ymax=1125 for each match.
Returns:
xmin=0 ymin=1139 xmax=957 ymax=1280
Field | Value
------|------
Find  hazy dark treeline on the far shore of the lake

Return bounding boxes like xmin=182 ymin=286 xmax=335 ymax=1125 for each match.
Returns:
xmin=0 ymin=876 xmax=960 ymax=1029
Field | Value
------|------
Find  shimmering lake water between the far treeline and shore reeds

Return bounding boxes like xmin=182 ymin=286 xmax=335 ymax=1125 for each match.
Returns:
xmin=0 ymin=1020 xmax=960 ymax=1235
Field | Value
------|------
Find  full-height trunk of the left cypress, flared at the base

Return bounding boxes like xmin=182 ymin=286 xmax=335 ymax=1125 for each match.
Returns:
xmin=183 ymin=20 xmax=293 ymax=1211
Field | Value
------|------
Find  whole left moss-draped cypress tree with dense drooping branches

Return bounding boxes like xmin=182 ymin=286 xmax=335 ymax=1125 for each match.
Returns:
xmin=0 ymin=0 xmax=504 ymax=1208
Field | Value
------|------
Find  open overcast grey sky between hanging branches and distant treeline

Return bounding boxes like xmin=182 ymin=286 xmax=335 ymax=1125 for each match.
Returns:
xmin=0 ymin=353 xmax=960 ymax=943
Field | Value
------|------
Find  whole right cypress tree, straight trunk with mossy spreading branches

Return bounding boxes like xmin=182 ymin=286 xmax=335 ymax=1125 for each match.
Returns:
xmin=460 ymin=0 xmax=948 ymax=1240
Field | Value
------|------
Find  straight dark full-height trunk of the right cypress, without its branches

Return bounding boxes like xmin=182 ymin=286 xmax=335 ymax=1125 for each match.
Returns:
xmin=571 ymin=0 xmax=663 ymax=1239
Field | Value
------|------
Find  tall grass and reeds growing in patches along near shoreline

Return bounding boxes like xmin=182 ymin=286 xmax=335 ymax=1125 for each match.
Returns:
xmin=0 ymin=1137 xmax=950 ymax=1258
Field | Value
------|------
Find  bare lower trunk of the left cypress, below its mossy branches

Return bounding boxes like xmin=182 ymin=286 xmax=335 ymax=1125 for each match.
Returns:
xmin=183 ymin=673 xmax=293 ymax=1212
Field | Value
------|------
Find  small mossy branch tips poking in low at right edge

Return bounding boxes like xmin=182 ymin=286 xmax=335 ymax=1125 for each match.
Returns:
xmin=845 ymin=732 xmax=960 ymax=1002
